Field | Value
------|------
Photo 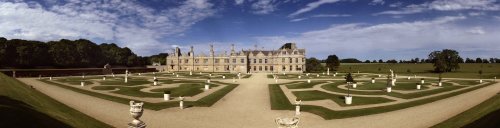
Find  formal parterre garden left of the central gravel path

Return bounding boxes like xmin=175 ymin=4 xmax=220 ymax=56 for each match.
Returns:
xmin=37 ymin=72 xmax=243 ymax=110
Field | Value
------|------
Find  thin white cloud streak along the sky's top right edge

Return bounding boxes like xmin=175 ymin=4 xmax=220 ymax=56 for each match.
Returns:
xmin=374 ymin=0 xmax=500 ymax=15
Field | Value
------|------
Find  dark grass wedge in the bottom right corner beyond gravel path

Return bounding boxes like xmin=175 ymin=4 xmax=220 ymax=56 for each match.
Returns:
xmin=432 ymin=94 xmax=500 ymax=128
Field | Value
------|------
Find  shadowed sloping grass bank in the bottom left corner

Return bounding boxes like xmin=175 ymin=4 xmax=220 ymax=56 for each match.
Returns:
xmin=0 ymin=73 xmax=111 ymax=128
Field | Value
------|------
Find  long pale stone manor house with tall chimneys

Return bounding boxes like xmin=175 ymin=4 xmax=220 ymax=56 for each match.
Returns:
xmin=165 ymin=43 xmax=306 ymax=73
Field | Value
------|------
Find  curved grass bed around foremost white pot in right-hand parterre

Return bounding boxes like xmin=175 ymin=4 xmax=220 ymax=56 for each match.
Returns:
xmin=292 ymin=90 xmax=394 ymax=106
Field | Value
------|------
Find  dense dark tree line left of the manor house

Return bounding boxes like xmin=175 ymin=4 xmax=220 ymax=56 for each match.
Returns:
xmin=0 ymin=37 xmax=168 ymax=68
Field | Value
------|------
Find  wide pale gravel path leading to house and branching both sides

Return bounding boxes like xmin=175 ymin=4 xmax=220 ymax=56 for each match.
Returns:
xmin=19 ymin=74 xmax=500 ymax=128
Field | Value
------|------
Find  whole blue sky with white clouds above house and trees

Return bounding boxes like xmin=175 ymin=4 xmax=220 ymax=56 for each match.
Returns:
xmin=0 ymin=0 xmax=500 ymax=60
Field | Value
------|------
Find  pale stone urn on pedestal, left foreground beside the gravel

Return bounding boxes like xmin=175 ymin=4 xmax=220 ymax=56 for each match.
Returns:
xmin=128 ymin=101 xmax=146 ymax=128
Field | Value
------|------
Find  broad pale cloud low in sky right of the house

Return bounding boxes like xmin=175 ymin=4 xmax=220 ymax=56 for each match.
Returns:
xmin=256 ymin=16 xmax=500 ymax=59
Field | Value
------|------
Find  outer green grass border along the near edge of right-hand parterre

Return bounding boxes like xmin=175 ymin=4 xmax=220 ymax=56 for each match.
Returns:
xmin=269 ymin=83 xmax=494 ymax=119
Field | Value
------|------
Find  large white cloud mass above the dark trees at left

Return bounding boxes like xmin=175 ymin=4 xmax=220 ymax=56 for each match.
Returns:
xmin=0 ymin=0 xmax=215 ymax=55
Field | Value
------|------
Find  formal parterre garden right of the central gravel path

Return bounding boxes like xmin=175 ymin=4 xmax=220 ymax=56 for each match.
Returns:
xmin=268 ymin=72 xmax=496 ymax=120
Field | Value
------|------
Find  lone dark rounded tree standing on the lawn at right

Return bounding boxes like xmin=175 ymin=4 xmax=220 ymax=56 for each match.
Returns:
xmin=429 ymin=49 xmax=460 ymax=72
